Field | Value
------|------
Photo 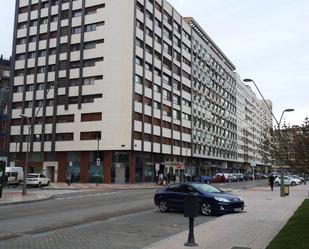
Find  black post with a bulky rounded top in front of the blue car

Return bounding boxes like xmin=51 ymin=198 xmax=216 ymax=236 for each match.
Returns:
xmin=183 ymin=193 xmax=200 ymax=247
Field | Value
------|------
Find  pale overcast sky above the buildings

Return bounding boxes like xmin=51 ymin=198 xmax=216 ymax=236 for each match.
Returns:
xmin=0 ymin=0 xmax=309 ymax=125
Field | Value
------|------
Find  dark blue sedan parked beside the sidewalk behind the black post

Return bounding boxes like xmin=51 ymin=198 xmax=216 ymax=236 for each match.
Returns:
xmin=154 ymin=183 xmax=244 ymax=215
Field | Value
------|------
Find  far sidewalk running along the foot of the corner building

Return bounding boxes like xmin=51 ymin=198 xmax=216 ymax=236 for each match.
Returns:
xmin=0 ymin=183 xmax=162 ymax=205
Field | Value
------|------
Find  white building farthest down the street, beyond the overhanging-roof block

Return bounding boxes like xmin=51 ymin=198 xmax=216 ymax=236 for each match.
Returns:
xmin=236 ymin=74 xmax=272 ymax=173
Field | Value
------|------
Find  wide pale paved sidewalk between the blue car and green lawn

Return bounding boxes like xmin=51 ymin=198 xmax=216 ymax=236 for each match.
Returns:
xmin=146 ymin=184 xmax=309 ymax=249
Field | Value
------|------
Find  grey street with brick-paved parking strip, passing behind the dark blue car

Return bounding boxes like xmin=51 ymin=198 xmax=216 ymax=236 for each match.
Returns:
xmin=0 ymin=181 xmax=266 ymax=249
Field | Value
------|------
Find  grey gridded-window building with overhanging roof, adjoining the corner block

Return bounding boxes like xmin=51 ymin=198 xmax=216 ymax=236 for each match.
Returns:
xmin=185 ymin=18 xmax=237 ymax=174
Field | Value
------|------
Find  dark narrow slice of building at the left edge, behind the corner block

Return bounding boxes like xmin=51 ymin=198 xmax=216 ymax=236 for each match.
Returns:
xmin=0 ymin=55 xmax=11 ymax=163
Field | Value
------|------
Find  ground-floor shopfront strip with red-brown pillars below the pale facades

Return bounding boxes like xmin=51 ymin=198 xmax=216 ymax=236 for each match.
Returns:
xmin=17 ymin=151 xmax=236 ymax=184
